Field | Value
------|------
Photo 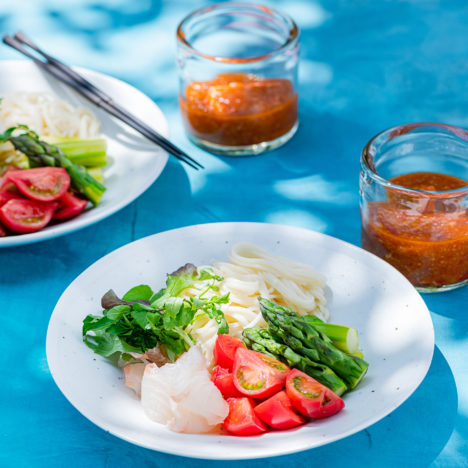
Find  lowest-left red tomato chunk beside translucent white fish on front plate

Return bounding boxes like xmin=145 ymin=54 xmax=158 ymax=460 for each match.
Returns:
xmin=223 ymin=397 xmax=267 ymax=435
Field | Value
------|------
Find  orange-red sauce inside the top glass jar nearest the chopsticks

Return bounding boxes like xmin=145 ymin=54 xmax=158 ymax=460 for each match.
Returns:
xmin=179 ymin=73 xmax=297 ymax=146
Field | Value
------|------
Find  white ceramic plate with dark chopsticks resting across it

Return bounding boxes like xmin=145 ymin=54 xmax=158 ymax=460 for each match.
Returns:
xmin=0 ymin=60 xmax=169 ymax=247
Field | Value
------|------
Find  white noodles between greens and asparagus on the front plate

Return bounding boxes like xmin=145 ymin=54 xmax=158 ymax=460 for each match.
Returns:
xmin=184 ymin=242 xmax=329 ymax=367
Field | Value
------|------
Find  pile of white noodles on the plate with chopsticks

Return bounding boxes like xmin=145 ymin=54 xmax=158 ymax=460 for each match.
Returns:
xmin=0 ymin=92 xmax=101 ymax=138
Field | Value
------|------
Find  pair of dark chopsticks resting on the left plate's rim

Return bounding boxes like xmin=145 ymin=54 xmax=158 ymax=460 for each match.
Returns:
xmin=3 ymin=32 xmax=204 ymax=170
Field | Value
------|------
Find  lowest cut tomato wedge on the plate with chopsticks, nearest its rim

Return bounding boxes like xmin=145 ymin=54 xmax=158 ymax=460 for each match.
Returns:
xmin=0 ymin=198 xmax=57 ymax=234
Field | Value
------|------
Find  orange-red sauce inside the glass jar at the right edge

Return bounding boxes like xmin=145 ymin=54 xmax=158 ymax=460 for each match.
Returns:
xmin=361 ymin=172 xmax=468 ymax=288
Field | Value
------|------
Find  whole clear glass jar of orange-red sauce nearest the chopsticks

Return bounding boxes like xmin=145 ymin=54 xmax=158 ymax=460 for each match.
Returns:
xmin=177 ymin=2 xmax=299 ymax=156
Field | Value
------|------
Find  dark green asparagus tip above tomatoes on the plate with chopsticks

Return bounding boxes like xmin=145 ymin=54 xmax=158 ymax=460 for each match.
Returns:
xmin=0 ymin=125 xmax=106 ymax=206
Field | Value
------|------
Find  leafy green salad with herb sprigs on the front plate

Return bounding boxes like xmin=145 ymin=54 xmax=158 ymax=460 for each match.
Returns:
xmin=82 ymin=263 xmax=229 ymax=361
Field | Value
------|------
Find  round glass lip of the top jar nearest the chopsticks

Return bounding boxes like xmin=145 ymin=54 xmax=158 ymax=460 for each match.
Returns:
xmin=176 ymin=2 xmax=299 ymax=64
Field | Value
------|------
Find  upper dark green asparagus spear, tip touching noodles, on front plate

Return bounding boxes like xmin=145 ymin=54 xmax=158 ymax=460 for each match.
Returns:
xmin=259 ymin=298 xmax=369 ymax=389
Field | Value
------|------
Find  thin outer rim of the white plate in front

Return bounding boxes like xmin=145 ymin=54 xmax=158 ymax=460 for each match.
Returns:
xmin=46 ymin=221 xmax=435 ymax=461
